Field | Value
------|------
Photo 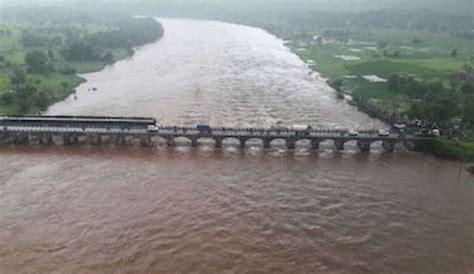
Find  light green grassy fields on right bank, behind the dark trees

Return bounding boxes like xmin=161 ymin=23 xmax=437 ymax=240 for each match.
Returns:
xmin=289 ymin=30 xmax=474 ymax=115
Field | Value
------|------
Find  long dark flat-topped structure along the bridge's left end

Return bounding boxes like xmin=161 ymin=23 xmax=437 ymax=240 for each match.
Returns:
xmin=0 ymin=116 xmax=157 ymax=130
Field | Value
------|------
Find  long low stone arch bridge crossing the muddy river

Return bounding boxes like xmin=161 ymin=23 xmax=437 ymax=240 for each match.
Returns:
xmin=0 ymin=115 xmax=435 ymax=152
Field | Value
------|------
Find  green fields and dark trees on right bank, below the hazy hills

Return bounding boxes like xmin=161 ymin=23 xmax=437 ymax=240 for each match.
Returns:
xmin=286 ymin=31 xmax=474 ymax=161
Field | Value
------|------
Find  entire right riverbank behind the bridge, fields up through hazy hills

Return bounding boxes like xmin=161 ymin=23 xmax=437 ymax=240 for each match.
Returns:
xmin=139 ymin=1 xmax=474 ymax=162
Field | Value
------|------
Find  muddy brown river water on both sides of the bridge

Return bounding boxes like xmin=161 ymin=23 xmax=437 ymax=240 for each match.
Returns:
xmin=0 ymin=19 xmax=474 ymax=273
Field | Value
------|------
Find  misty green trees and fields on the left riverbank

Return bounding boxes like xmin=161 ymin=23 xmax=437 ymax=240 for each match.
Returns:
xmin=0 ymin=9 xmax=164 ymax=114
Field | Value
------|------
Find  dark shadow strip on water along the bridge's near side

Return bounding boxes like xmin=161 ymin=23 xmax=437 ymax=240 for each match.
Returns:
xmin=0 ymin=142 xmax=408 ymax=163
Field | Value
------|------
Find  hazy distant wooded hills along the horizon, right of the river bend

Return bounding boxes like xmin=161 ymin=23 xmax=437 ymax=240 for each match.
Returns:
xmin=139 ymin=0 xmax=473 ymax=35
